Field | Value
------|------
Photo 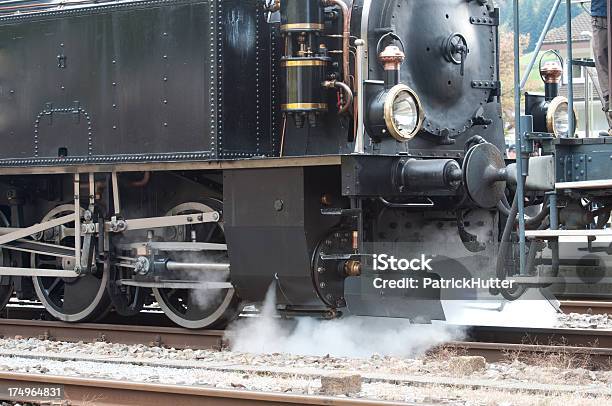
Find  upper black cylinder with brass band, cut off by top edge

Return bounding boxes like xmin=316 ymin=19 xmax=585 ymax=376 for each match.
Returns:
xmin=280 ymin=0 xmax=325 ymax=32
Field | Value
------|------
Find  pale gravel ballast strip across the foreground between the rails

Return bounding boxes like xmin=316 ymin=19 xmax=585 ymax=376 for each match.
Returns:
xmin=0 ymin=338 xmax=612 ymax=406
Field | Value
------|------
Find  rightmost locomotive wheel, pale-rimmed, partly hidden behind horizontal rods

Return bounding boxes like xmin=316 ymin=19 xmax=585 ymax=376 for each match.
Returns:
xmin=153 ymin=199 xmax=240 ymax=329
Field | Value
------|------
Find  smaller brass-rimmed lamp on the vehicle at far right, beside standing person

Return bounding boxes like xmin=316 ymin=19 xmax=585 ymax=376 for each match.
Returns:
xmin=525 ymin=61 xmax=576 ymax=137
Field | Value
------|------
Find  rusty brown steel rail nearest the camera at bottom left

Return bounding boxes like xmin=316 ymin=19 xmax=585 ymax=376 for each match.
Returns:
xmin=0 ymin=372 xmax=406 ymax=406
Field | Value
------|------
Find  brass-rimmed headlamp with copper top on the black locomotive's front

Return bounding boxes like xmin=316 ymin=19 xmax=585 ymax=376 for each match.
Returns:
xmin=367 ymin=45 xmax=425 ymax=142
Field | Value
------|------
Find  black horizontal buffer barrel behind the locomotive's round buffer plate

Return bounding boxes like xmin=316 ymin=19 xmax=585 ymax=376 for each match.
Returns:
xmin=396 ymin=159 xmax=462 ymax=192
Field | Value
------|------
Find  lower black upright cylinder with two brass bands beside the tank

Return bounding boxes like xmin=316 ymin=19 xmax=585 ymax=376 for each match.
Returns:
xmin=281 ymin=57 xmax=329 ymax=113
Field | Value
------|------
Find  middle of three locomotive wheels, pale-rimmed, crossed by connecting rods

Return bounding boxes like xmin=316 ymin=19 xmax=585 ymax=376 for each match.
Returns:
xmin=30 ymin=204 xmax=110 ymax=322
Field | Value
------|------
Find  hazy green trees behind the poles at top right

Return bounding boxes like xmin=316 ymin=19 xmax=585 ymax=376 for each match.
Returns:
xmin=495 ymin=0 xmax=584 ymax=52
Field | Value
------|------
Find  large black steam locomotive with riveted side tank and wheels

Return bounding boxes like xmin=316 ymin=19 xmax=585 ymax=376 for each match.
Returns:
xmin=0 ymin=0 xmax=508 ymax=328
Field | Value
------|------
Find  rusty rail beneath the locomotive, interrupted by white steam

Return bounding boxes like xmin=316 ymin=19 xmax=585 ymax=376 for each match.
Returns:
xmin=0 ymin=319 xmax=612 ymax=365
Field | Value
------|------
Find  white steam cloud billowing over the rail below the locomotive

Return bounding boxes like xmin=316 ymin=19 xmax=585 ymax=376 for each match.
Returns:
xmin=226 ymin=286 xmax=462 ymax=358
